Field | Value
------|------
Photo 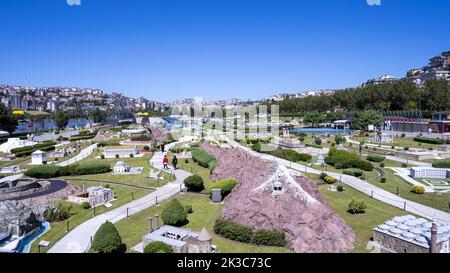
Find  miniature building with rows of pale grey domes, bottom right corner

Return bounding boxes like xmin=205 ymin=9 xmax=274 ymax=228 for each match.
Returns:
xmin=373 ymin=215 xmax=450 ymax=253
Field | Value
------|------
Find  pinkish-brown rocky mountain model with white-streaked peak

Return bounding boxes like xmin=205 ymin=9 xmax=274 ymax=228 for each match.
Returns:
xmin=201 ymin=144 xmax=355 ymax=253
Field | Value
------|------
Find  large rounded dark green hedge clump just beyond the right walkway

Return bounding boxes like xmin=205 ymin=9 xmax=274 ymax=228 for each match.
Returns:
xmin=325 ymin=148 xmax=373 ymax=172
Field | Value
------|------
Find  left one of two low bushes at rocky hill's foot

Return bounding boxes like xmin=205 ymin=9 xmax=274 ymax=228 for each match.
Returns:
xmin=214 ymin=219 xmax=253 ymax=243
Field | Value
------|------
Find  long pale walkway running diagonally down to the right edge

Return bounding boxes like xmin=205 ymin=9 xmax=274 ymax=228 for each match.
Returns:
xmin=227 ymin=139 xmax=450 ymax=223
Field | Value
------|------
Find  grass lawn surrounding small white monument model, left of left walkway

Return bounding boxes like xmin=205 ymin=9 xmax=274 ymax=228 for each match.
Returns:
xmin=59 ymin=154 xmax=172 ymax=187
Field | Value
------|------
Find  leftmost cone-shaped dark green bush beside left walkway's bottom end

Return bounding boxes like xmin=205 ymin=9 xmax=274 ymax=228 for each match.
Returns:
xmin=92 ymin=221 xmax=124 ymax=253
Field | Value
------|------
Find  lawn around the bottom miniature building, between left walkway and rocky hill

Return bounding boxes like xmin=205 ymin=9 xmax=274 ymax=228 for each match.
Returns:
xmin=116 ymin=193 xmax=290 ymax=253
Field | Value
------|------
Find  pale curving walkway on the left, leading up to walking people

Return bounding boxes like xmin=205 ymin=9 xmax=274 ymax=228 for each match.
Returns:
xmin=48 ymin=143 xmax=191 ymax=253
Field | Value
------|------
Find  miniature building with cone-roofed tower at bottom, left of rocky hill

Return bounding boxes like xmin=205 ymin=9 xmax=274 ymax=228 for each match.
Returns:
xmin=142 ymin=216 xmax=214 ymax=253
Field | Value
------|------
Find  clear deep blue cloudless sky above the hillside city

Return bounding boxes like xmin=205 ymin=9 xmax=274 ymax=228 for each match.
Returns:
xmin=0 ymin=0 xmax=450 ymax=101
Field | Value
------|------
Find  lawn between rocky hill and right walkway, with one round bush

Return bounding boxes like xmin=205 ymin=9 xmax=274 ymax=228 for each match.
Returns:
xmin=308 ymin=174 xmax=410 ymax=253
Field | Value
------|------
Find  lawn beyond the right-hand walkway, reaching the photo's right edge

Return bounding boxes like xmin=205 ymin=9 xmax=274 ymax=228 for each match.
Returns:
xmin=369 ymin=168 xmax=450 ymax=211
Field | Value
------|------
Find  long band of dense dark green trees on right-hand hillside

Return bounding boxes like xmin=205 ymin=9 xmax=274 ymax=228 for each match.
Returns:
xmin=269 ymin=79 xmax=450 ymax=116
